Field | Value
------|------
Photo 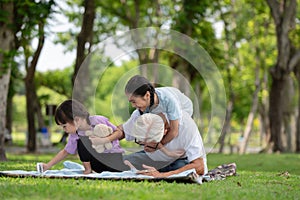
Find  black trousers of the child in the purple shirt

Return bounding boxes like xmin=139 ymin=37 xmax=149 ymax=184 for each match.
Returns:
xmin=77 ymin=139 xmax=118 ymax=173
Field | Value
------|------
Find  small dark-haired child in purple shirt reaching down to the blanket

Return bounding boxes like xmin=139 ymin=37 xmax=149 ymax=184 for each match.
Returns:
xmin=40 ymin=100 xmax=124 ymax=174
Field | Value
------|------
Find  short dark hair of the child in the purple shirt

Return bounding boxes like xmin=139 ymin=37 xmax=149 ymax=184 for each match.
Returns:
xmin=54 ymin=99 xmax=90 ymax=125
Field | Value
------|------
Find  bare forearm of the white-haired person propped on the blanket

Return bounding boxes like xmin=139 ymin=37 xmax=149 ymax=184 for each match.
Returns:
xmin=142 ymin=158 xmax=204 ymax=178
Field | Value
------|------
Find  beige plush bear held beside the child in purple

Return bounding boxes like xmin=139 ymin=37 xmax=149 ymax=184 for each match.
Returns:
xmin=85 ymin=124 xmax=113 ymax=153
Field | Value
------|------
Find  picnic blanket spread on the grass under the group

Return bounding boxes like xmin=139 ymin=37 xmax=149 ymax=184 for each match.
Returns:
xmin=0 ymin=161 xmax=236 ymax=184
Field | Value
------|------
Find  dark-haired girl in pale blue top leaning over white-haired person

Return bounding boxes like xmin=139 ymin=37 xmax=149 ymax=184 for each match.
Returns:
xmin=125 ymin=75 xmax=193 ymax=152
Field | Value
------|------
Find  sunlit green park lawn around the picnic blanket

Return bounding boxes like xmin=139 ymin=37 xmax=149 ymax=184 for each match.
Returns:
xmin=0 ymin=154 xmax=300 ymax=200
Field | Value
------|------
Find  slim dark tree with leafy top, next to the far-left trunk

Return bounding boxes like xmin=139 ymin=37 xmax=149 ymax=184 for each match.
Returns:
xmin=14 ymin=0 xmax=54 ymax=152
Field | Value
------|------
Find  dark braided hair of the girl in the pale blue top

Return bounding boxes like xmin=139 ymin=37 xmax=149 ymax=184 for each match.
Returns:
xmin=125 ymin=75 xmax=155 ymax=114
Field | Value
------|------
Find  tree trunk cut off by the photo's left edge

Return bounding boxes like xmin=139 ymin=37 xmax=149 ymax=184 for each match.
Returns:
xmin=0 ymin=1 xmax=14 ymax=161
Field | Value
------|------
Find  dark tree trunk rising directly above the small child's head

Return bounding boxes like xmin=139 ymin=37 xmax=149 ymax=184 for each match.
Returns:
xmin=72 ymin=0 xmax=96 ymax=103
